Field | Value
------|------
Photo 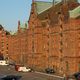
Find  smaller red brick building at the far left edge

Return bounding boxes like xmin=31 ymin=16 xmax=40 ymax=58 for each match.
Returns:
xmin=0 ymin=25 xmax=9 ymax=59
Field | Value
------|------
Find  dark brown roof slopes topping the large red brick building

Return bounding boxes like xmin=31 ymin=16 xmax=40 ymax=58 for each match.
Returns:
xmin=38 ymin=1 xmax=80 ymax=22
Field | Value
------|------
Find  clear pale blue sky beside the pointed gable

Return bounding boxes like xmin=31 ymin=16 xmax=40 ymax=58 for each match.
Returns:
xmin=0 ymin=0 xmax=80 ymax=31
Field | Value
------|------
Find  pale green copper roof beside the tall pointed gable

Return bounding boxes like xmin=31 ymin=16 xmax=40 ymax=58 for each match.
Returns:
xmin=35 ymin=1 xmax=61 ymax=14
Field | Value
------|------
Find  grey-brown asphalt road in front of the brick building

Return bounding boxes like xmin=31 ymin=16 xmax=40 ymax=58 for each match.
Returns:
xmin=0 ymin=66 xmax=63 ymax=80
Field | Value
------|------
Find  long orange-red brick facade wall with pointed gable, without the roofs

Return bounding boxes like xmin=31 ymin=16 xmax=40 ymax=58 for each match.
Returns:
xmin=8 ymin=2 xmax=80 ymax=74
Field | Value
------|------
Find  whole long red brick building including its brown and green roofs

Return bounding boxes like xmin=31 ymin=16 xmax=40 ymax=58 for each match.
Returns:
xmin=8 ymin=0 xmax=80 ymax=74
